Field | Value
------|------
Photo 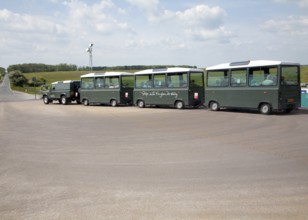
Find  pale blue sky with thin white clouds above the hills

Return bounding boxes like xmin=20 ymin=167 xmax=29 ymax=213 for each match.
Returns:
xmin=0 ymin=0 xmax=308 ymax=68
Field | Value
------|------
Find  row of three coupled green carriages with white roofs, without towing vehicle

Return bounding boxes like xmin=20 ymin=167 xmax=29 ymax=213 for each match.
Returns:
xmin=42 ymin=60 xmax=301 ymax=114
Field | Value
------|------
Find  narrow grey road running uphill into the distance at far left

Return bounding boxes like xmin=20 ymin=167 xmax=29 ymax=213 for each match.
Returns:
xmin=0 ymin=74 xmax=35 ymax=102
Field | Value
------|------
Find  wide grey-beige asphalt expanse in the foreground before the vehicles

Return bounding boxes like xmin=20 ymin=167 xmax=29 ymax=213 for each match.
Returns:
xmin=0 ymin=76 xmax=308 ymax=220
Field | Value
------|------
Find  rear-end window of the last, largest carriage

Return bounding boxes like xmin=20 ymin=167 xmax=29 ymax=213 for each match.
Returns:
xmin=281 ymin=66 xmax=299 ymax=85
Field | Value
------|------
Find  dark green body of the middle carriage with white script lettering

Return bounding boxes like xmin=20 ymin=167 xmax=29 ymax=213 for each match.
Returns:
xmin=134 ymin=68 xmax=204 ymax=107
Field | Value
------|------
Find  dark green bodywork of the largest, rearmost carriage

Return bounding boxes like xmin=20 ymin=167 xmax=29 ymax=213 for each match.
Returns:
xmin=205 ymin=65 xmax=301 ymax=111
